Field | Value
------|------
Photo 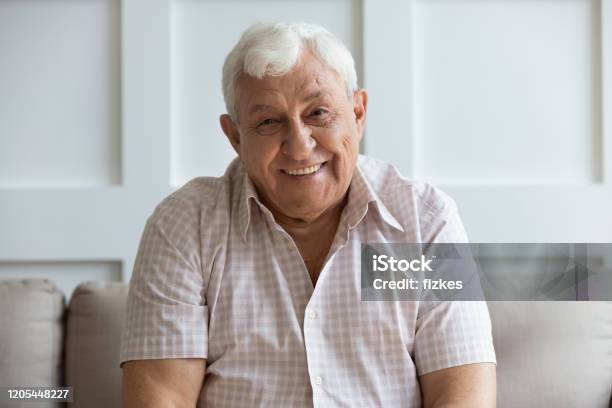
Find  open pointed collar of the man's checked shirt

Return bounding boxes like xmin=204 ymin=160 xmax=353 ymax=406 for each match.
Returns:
xmin=238 ymin=159 xmax=404 ymax=241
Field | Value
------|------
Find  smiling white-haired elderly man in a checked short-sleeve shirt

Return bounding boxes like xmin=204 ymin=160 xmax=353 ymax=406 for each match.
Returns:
xmin=121 ymin=24 xmax=495 ymax=408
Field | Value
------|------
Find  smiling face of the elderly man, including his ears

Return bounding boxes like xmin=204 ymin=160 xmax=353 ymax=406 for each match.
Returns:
xmin=221 ymin=49 xmax=367 ymax=225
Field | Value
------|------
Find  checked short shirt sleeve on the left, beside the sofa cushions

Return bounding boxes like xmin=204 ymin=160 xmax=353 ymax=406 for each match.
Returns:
xmin=120 ymin=198 xmax=208 ymax=364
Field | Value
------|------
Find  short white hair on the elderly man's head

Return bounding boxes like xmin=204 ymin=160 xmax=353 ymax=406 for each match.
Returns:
xmin=222 ymin=23 xmax=358 ymax=120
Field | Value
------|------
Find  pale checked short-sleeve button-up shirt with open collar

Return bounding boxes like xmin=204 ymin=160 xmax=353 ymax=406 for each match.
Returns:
xmin=121 ymin=156 xmax=495 ymax=408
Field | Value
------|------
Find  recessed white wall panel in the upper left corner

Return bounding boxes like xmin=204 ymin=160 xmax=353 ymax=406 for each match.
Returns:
xmin=0 ymin=0 xmax=121 ymax=188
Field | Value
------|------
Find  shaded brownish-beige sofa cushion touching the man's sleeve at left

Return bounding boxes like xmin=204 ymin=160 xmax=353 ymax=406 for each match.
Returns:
xmin=66 ymin=282 xmax=127 ymax=408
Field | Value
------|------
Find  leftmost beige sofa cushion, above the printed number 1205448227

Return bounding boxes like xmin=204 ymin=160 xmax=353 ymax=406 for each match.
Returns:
xmin=0 ymin=279 xmax=65 ymax=408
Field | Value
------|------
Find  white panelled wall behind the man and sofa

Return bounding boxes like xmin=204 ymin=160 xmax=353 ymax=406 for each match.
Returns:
xmin=0 ymin=0 xmax=612 ymax=300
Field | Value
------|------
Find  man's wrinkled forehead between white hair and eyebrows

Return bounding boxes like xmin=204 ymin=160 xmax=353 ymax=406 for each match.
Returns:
xmin=236 ymin=51 xmax=345 ymax=109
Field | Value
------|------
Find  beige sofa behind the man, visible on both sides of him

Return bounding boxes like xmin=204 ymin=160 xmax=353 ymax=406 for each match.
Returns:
xmin=0 ymin=280 xmax=612 ymax=408
